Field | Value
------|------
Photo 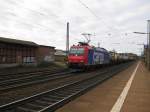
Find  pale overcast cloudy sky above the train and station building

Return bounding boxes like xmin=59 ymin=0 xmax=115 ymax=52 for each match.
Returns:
xmin=0 ymin=0 xmax=150 ymax=54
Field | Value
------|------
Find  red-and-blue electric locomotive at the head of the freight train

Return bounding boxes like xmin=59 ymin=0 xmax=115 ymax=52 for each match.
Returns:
xmin=68 ymin=42 xmax=110 ymax=68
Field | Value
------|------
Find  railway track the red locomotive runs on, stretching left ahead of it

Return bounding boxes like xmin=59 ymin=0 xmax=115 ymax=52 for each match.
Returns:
xmin=0 ymin=69 xmax=79 ymax=92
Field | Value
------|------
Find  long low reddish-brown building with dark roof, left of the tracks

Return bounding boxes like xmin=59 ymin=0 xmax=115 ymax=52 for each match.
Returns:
xmin=0 ymin=37 xmax=55 ymax=67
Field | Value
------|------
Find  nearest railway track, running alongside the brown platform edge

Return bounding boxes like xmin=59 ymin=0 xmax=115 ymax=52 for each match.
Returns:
xmin=0 ymin=63 xmax=132 ymax=112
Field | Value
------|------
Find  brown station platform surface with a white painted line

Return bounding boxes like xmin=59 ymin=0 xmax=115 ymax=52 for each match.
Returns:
xmin=56 ymin=62 xmax=150 ymax=112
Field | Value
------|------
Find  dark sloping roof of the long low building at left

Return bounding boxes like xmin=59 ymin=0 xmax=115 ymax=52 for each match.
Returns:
xmin=0 ymin=37 xmax=38 ymax=46
